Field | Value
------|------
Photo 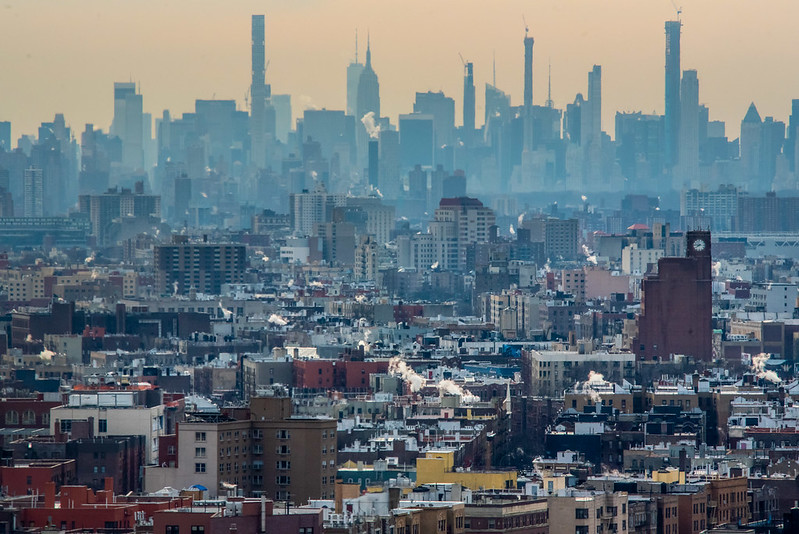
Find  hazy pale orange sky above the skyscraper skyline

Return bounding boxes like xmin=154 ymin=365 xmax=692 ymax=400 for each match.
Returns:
xmin=0 ymin=0 xmax=799 ymax=140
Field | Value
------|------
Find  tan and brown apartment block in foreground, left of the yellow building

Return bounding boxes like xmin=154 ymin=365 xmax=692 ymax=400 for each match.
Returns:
xmin=145 ymin=397 xmax=336 ymax=504
